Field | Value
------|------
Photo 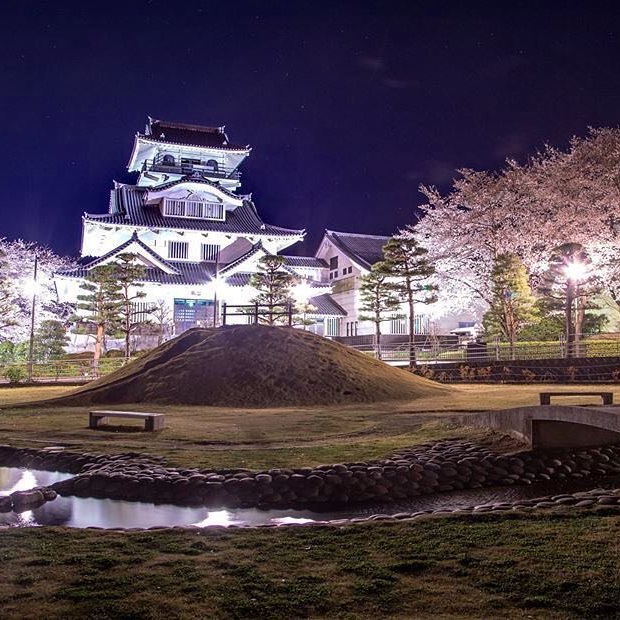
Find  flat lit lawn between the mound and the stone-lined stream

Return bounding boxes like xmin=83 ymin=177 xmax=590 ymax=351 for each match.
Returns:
xmin=0 ymin=385 xmax=620 ymax=469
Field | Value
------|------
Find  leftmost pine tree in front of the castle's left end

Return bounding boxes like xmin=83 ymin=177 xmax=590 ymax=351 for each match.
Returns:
xmin=77 ymin=263 xmax=123 ymax=369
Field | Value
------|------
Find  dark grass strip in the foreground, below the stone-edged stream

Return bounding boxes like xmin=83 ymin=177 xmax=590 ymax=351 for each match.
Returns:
xmin=0 ymin=511 xmax=620 ymax=618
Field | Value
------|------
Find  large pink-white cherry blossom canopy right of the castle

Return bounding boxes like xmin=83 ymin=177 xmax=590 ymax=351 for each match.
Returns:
xmin=415 ymin=128 xmax=620 ymax=324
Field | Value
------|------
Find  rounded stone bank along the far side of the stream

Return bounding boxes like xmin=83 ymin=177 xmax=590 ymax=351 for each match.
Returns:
xmin=0 ymin=440 xmax=620 ymax=510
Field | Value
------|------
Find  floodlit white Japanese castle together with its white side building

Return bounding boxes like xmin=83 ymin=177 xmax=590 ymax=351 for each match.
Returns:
xmin=56 ymin=118 xmax=450 ymax=348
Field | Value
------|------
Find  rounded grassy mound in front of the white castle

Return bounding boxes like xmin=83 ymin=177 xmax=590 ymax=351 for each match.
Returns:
xmin=55 ymin=325 xmax=450 ymax=407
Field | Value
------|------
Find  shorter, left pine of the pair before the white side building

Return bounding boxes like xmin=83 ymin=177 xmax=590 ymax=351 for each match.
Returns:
xmin=359 ymin=262 xmax=400 ymax=359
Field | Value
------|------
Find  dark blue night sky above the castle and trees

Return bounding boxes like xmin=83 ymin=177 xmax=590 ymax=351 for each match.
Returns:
xmin=0 ymin=0 xmax=620 ymax=255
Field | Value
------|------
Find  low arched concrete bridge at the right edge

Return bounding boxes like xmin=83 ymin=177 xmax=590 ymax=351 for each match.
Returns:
xmin=458 ymin=405 xmax=620 ymax=448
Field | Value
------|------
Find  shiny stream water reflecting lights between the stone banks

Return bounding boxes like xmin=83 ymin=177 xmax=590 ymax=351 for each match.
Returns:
xmin=0 ymin=467 xmax=620 ymax=528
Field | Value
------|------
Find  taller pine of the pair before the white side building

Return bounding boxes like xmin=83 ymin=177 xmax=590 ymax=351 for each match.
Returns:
xmin=382 ymin=232 xmax=437 ymax=367
